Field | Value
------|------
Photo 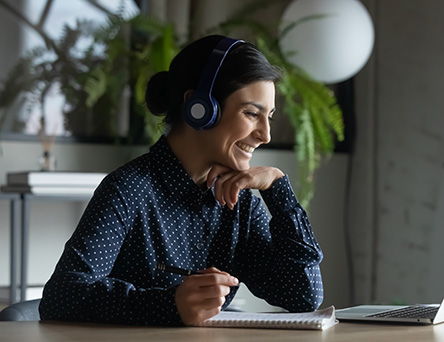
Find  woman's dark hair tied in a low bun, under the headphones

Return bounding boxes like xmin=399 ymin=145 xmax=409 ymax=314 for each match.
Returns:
xmin=145 ymin=35 xmax=280 ymax=125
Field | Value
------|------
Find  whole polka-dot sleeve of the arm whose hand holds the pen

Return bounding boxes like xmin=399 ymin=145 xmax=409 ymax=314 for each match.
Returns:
xmin=40 ymin=178 xmax=182 ymax=325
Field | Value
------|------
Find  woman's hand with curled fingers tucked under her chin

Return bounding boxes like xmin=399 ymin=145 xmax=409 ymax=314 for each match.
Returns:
xmin=207 ymin=165 xmax=284 ymax=209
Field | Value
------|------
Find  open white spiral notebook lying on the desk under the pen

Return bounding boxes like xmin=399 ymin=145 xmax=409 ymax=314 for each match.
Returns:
xmin=194 ymin=306 xmax=338 ymax=330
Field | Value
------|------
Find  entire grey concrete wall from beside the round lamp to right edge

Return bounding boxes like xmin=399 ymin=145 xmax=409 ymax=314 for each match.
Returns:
xmin=352 ymin=0 xmax=444 ymax=303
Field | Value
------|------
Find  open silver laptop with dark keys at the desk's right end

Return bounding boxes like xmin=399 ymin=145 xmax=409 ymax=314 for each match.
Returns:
xmin=336 ymin=300 xmax=444 ymax=324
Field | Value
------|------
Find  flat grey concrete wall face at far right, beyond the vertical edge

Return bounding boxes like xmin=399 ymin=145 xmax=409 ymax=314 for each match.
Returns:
xmin=366 ymin=0 xmax=444 ymax=302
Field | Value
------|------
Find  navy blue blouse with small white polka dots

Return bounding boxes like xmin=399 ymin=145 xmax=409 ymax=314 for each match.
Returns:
xmin=40 ymin=136 xmax=323 ymax=325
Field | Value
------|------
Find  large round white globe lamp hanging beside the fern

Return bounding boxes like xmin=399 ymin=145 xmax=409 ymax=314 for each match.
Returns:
xmin=281 ymin=0 xmax=375 ymax=83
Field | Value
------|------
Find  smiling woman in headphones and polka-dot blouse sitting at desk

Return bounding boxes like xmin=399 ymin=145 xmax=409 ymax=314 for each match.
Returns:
xmin=40 ymin=36 xmax=323 ymax=325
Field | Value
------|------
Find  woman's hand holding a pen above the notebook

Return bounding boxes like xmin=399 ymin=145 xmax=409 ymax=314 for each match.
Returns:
xmin=176 ymin=267 xmax=239 ymax=325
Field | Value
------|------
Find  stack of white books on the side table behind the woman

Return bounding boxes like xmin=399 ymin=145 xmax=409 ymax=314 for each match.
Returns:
xmin=1 ymin=171 xmax=106 ymax=195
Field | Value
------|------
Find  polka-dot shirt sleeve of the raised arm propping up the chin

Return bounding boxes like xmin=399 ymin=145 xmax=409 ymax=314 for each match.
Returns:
xmin=234 ymin=176 xmax=323 ymax=312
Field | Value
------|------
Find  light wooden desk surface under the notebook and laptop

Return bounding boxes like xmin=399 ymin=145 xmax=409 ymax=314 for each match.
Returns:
xmin=0 ymin=322 xmax=444 ymax=342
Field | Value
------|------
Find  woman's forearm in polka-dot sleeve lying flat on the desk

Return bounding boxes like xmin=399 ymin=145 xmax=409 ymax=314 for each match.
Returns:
xmin=40 ymin=272 xmax=181 ymax=325
